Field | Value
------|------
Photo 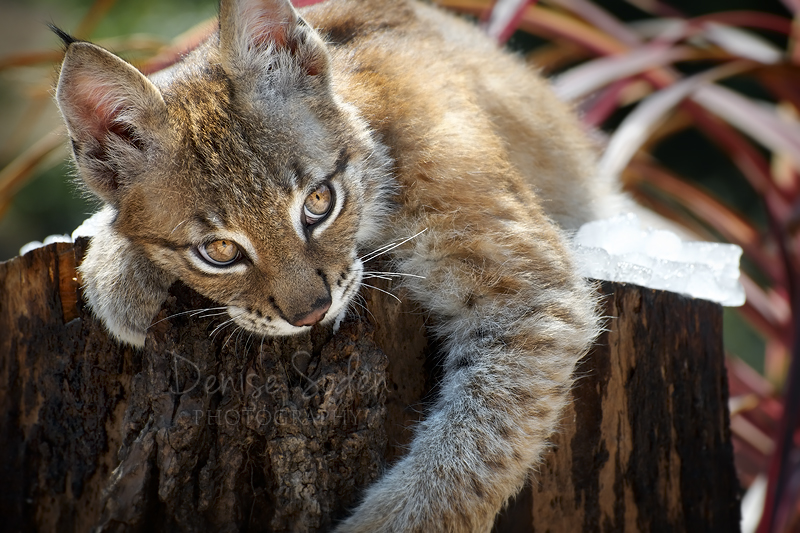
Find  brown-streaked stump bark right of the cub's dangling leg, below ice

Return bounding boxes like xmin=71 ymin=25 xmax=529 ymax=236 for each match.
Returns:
xmin=502 ymin=282 xmax=740 ymax=533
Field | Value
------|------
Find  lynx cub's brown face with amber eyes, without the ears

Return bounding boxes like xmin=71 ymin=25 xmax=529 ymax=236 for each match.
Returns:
xmin=116 ymin=61 xmax=388 ymax=335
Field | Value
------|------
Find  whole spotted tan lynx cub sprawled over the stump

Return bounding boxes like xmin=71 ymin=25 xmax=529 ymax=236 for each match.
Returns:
xmin=57 ymin=0 xmax=615 ymax=532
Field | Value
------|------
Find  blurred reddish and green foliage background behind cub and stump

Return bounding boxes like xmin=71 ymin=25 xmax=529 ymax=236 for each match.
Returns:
xmin=0 ymin=0 xmax=800 ymax=532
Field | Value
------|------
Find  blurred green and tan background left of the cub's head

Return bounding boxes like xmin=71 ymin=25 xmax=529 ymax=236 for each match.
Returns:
xmin=0 ymin=0 xmax=217 ymax=260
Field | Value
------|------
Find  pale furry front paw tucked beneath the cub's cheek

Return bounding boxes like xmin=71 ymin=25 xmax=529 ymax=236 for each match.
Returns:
xmin=79 ymin=215 xmax=174 ymax=347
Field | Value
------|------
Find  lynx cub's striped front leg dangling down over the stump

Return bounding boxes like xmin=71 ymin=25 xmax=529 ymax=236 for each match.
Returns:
xmin=338 ymin=214 xmax=598 ymax=533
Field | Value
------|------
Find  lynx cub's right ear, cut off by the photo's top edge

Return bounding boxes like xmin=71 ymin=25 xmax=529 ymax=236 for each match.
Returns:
xmin=219 ymin=0 xmax=328 ymax=76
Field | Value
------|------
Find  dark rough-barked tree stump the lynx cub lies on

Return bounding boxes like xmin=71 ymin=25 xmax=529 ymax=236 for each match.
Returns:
xmin=0 ymin=241 xmax=739 ymax=533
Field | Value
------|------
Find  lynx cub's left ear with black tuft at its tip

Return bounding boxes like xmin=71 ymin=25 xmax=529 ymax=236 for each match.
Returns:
xmin=56 ymin=41 xmax=166 ymax=204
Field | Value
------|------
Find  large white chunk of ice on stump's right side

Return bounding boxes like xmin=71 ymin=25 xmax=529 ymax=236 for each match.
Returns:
xmin=573 ymin=213 xmax=745 ymax=307
